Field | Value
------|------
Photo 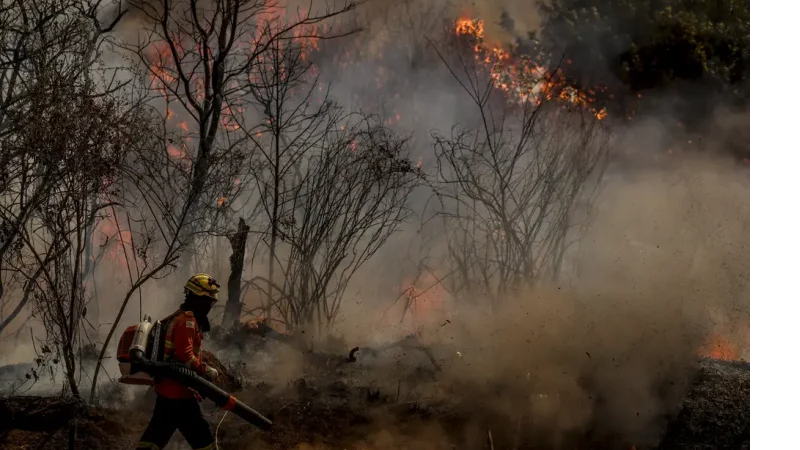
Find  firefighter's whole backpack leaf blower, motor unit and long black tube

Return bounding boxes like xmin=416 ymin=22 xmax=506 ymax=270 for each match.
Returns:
xmin=117 ymin=315 xmax=272 ymax=431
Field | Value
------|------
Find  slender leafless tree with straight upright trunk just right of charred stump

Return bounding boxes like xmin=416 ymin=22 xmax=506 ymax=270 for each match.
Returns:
xmin=230 ymin=14 xmax=335 ymax=326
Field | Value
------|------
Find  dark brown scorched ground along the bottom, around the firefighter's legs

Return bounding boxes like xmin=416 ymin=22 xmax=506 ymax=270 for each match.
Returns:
xmin=0 ymin=359 xmax=752 ymax=450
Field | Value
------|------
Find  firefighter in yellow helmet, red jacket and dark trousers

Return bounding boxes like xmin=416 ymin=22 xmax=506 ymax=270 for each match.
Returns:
xmin=136 ymin=273 xmax=220 ymax=450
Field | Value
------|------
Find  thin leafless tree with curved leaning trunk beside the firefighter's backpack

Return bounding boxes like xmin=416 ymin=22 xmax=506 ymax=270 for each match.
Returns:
xmin=90 ymin=92 xmax=245 ymax=401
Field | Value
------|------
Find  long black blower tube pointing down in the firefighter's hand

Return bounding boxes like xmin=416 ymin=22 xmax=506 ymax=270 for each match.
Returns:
xmin=130 ymin=349 xmax=272 ymax=431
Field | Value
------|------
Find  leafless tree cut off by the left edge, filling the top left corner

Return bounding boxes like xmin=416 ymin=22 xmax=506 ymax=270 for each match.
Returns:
xmin=0 ymin=0 xmax=124 ymax=330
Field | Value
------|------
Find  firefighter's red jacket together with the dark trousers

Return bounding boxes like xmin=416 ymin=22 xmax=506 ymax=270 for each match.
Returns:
xmin=136 ymin=309 xmax=216 ymax=450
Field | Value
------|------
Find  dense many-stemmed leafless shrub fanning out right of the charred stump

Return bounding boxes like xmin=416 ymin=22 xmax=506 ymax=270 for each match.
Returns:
xmin=250 ymin=110 xmax=420 ymax=331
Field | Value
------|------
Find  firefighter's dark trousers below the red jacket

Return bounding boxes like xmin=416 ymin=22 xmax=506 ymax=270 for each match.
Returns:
xmin=136 ymin=396 xmax=216 ymax=450
